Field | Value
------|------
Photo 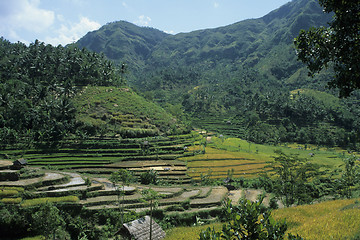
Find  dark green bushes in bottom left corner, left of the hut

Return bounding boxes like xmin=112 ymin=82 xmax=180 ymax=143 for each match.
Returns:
xmin=0 ymin=203 xmax=136 ymax=240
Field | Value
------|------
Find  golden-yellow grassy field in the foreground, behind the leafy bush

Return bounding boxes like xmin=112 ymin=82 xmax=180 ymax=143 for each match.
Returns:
xmin=165 ymin=199 xmax=360 ymax=240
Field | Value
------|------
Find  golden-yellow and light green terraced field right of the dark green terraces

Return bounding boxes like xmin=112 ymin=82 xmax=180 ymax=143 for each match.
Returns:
xmin=179 ymin=133 xmax=360 ymax=180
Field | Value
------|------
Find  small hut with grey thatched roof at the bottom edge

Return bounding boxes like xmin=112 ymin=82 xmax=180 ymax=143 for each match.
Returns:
xmin=119 ymin=216 xmax=165 ymax=240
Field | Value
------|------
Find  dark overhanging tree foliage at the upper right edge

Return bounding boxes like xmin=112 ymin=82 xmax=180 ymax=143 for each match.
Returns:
xmin=294 ymin=0 xmax=360 ymax=97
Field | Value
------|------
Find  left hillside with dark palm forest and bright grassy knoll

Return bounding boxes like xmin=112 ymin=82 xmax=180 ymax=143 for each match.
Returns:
xmin=0 ymin=38 xmax=188 ymax=148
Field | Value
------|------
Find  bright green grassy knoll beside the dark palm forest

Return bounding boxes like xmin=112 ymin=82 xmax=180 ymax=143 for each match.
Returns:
xmin=75 ymin=86 xmax=180 ymax=135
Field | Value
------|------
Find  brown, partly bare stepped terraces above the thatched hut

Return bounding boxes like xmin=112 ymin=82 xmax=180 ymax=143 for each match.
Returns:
xmin=0 ymin=161 xmax=228 ymax=214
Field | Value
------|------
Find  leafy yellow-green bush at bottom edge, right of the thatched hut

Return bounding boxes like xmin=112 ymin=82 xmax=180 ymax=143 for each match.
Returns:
xmin=199 ymin=198 xmax=302 ymax=240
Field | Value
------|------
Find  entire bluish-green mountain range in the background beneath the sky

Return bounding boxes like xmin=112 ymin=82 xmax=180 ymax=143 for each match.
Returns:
xmin=77 ymin=0 xmax=331 ymax=87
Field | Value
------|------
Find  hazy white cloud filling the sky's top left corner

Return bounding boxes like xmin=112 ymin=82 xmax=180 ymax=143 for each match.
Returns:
xmin=0 ymin=0 xmax=55 ymax=37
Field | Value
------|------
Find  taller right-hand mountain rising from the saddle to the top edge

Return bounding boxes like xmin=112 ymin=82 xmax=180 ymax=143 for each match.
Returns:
xmin=148 ymin=0 xmax=331 ymax=83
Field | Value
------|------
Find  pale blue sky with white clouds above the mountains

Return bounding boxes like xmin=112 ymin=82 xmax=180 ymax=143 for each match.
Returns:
xmin=0 ymin=0 xmax=290 ymax=46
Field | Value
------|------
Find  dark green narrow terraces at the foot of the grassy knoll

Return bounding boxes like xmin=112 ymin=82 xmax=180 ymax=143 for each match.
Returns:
xmin=4 ymin=133 xmax=201 ymax=184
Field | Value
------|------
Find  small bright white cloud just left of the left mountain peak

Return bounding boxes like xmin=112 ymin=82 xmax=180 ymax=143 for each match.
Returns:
xmin=45 ymin=17 xmax=101 ymax=46
